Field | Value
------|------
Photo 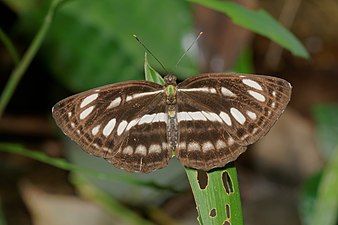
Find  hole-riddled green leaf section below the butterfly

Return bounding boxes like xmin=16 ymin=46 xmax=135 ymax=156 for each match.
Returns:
xmin=185 ymin=163 xmax=243 ymax=225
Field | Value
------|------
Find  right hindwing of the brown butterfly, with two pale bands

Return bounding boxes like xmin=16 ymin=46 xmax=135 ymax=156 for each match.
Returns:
xmin=176 ymin=95 xmax=245 ymax=170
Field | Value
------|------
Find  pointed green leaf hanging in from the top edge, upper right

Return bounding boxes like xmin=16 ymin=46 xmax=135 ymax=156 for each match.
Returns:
xmin=188 ymin=0 xmax=309 ymax=58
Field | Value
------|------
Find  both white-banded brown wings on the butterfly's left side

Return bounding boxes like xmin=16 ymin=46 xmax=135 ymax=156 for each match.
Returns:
xmin=53 ymin=81 xmax=169 ymax=172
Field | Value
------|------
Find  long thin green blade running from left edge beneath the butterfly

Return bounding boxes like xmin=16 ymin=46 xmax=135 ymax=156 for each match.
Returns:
xmin=0 ymin=143 xmax=178 ymax=192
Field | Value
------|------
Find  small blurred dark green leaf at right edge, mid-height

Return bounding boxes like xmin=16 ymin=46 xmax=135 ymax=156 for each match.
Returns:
xmin=313 ymin=105 xmax=338 ymax=159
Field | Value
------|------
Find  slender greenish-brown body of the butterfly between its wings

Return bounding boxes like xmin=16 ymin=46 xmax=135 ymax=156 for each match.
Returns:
xmin=164 ymin=75 xmax=179 ymax=151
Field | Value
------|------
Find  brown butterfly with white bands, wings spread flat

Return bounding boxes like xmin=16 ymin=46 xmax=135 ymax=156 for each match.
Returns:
xmin=52 ymin=73 xmax=292 ymax=173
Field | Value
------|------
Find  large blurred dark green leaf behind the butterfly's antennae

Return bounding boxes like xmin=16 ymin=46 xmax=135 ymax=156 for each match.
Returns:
xmin=18 ymin=0 xmax=196 ymax=91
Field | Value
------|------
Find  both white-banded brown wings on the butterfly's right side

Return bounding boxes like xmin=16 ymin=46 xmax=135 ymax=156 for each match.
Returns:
xmin=176 ymin=74 xmax=291 ymax=170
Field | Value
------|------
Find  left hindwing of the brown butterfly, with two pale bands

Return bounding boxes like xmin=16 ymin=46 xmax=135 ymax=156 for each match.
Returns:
xmin=107 ymin=96 xmax=172 ymax=173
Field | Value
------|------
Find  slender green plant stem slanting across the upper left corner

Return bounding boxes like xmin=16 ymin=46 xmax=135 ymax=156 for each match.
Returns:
xmin=0 ymin=0 xmax=63 ymax=118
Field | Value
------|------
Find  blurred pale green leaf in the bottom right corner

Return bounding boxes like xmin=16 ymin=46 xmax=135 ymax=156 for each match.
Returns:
xmin=310 ymin=146 xmax=338 ymax=225
